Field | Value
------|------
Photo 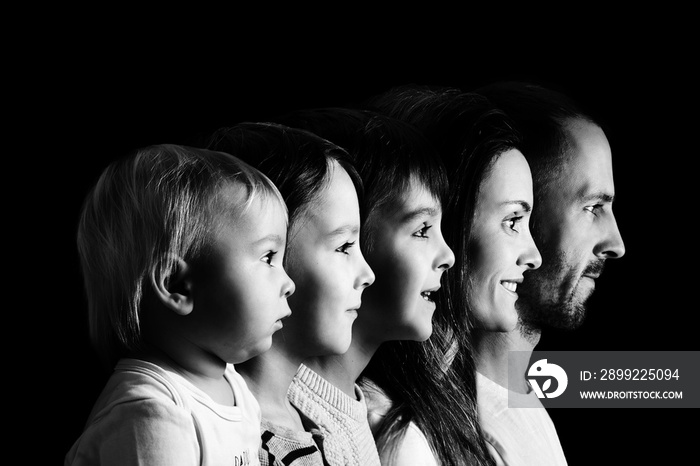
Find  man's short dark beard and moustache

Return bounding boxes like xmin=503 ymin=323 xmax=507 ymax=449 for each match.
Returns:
xmin=515 ymin=249 xmax=605 ymax=333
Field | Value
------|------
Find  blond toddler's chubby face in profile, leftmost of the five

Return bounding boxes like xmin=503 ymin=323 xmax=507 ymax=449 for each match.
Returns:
xmin=186 ymin=187 xmax=294 ymax=364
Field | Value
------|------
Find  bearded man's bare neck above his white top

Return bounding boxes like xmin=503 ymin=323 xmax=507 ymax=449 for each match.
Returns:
xmin=475 ymin=324 xmax=541 ymax=393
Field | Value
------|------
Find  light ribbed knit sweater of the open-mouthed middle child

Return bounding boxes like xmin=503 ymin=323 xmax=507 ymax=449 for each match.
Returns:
xmin=288 ymin=364 xmax=380 ymax=466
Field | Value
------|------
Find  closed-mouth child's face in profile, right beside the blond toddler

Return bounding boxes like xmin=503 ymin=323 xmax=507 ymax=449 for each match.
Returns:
xmin=280 ymin=162 xmax=374 ymax=357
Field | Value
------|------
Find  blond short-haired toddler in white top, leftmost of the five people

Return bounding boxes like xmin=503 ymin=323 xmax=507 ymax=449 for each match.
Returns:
xmin=65 ymin=145 xmax=294 ymax=465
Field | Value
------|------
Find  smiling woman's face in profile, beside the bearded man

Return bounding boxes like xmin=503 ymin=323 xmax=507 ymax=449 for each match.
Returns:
xmin=467 ymin=149 xmax=542 ymax=332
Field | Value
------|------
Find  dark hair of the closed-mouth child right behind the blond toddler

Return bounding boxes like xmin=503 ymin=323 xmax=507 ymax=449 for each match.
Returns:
xmin=207 ymin=122 xmax=363 ymax=238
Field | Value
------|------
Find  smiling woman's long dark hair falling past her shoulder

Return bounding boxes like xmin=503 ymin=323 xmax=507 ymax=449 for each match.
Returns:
xmin=368 ymin=86 xmax=520 ymax=464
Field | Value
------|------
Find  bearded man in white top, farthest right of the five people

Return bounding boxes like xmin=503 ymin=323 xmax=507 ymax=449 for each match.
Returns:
xmin=476 ymin=82 xmax=625 ymax=465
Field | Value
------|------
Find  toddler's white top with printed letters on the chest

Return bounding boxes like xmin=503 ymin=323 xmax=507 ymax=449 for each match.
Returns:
xmin=65 ymin=359 xmax=261 ymax=466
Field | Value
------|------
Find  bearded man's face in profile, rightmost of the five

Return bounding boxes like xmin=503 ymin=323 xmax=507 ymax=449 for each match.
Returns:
xmin=519 ymin=120 xmax=625 ymax=328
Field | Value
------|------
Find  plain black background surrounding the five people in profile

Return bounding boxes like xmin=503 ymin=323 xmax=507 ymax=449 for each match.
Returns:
xmin=21 ymin=24 xmax=698 ymax=465
